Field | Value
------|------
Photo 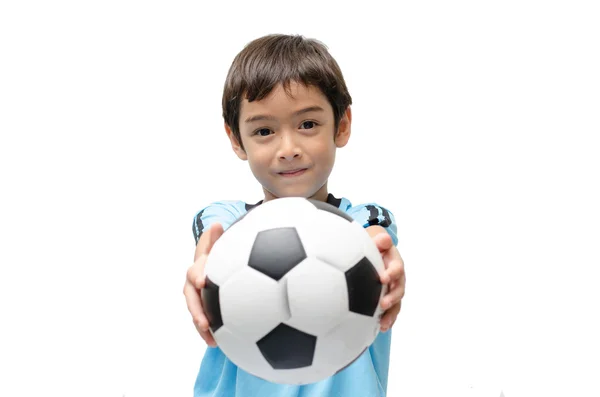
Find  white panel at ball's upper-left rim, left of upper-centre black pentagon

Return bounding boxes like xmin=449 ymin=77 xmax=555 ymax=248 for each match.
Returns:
xmin=204 ymin=220 xmax=256 ymax=286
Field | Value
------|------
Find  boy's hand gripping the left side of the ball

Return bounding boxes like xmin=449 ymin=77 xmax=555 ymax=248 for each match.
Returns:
xmin=183 ymin=223 xmax=224 ymax=347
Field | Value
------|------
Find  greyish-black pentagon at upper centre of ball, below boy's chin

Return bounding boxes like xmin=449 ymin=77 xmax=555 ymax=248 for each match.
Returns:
xmin=248 ymin=227 xmax=306 ymax=281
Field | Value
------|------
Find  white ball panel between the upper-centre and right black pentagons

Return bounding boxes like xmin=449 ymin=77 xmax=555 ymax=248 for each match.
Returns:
xmin=296 ymin=211 xmax=366 ymax=272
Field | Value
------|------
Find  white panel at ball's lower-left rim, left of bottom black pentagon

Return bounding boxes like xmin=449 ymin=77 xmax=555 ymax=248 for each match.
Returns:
xmin=213 ymin=326 xmax=272 ymax=376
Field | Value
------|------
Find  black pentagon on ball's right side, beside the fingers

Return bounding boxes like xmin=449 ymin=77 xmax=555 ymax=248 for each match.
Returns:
xmin=346 ymin=257 xmax=383 ymax=316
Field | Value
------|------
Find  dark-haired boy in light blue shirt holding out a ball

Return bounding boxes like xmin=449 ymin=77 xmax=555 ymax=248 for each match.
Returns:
xmin=184 ymin=35 xmax=405 ymax=397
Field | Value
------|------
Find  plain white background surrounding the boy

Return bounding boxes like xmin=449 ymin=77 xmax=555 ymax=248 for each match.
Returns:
xmin=0 ymin=0 xmax=600 ymax=397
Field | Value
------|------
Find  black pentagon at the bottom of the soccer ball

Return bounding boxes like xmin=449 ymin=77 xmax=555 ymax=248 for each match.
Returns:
xmin=256 ymin=324 xmax=317 ymax=369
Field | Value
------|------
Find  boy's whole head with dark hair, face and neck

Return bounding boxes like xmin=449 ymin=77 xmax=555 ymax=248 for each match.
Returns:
xmin=223 ymin=35 xmax=352 ymax=200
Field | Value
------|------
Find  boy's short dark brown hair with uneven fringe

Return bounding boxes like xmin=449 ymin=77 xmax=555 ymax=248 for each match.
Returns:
xmin=222 ymin=34 xmax=352 ymax=149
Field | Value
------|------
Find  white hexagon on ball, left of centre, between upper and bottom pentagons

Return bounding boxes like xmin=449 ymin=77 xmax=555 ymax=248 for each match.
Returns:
xmin=219 ymin=267 xmax=290 ymax=342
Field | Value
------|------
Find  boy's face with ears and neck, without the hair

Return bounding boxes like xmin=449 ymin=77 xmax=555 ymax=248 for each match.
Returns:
xmin=225 ymin=83 xmax=352 ymax=201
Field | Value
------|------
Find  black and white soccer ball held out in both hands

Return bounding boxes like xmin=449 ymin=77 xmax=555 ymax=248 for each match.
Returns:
xmin=201 ymin=197 xmax=386 ymax=385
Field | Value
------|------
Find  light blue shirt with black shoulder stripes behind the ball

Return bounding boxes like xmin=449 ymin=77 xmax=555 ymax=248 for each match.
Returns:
xmin=193 ymin=194 xmax=398 ymax=397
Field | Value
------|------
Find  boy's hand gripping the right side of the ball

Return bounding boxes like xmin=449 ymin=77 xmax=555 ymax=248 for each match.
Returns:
xmin=372 ymin=232 xmax=406 ymax=332
